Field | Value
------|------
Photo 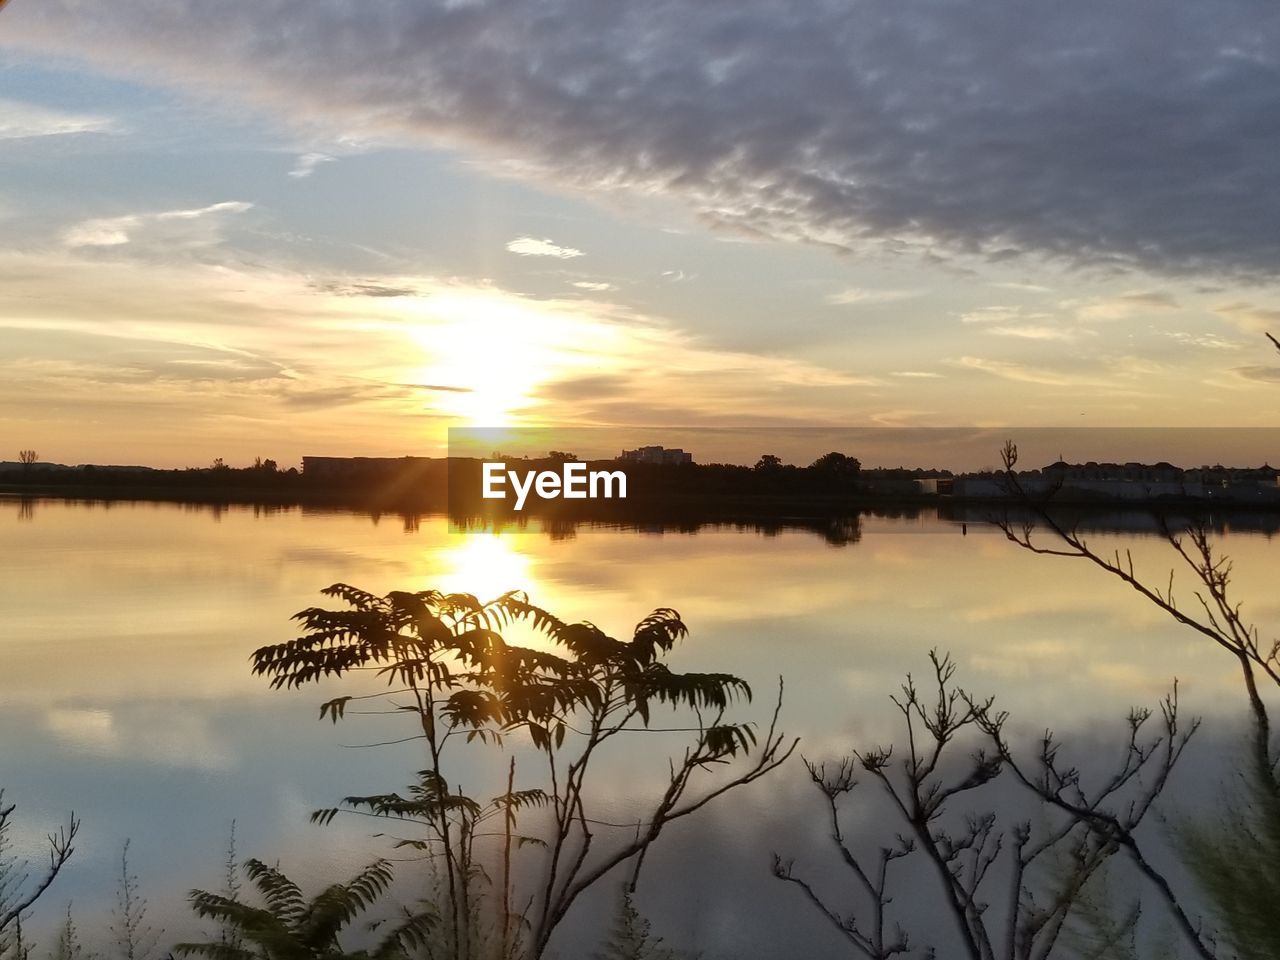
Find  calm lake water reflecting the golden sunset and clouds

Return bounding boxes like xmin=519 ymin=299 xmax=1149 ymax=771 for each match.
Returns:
xmin=0 ymin=500 xmax=1280 ymax=955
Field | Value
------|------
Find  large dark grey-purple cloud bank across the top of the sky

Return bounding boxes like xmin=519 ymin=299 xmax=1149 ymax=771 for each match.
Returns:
xmin=4 ymin=0 xmax=1280 ymax=276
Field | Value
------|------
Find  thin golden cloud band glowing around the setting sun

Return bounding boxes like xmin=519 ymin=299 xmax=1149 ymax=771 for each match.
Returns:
xmin=0 ymin=240 xmax=876 ymax=450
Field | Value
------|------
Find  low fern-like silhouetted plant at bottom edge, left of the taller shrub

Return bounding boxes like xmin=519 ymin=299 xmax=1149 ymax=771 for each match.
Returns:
xmin=174 ymin=860 xmax=438 ymax=960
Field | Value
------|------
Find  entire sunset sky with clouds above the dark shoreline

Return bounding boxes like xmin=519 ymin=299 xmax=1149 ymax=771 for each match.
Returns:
xmin=0 ymin=0 xmax=1280 ymax=466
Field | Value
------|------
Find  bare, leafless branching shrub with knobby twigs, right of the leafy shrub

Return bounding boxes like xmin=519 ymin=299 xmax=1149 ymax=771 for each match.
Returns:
xmin=773 ymin=652 xmax=1197 ymax=960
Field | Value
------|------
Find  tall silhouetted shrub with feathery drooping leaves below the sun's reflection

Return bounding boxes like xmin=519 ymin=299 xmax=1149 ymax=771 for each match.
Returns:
xmin=253 ymin=584 xmax=795 ymax=960
